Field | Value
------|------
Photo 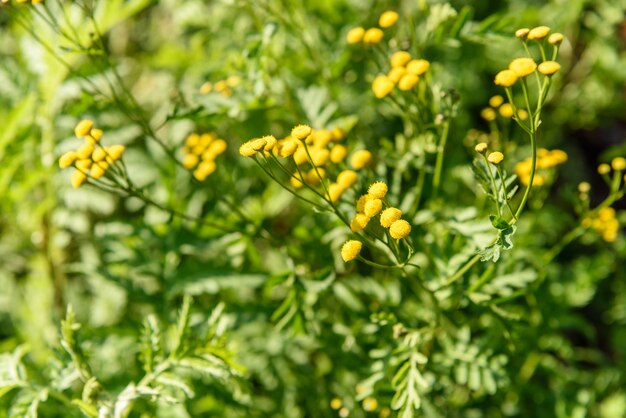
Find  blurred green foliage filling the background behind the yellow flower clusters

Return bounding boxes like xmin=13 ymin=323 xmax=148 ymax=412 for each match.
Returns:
xmin=0 ymin=0 xmax=626 ymax=418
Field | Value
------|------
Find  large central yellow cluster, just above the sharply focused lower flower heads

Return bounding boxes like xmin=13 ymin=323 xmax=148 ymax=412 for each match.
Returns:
xmin=239 ymin=125 xmax=373 ymax=202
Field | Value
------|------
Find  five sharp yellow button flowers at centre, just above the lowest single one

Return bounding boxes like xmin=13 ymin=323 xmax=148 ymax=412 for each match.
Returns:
xmin=350 ymin=181 xmax=411 ymax=239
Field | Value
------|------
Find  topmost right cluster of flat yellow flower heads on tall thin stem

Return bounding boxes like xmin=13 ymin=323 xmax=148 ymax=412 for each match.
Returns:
xmin=494 ymin=26 xmax=563 ymax=87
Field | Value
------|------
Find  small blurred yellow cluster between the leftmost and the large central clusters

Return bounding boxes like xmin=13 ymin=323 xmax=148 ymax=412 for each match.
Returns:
xmin=183 ymin=133 xmax=228 ymax=181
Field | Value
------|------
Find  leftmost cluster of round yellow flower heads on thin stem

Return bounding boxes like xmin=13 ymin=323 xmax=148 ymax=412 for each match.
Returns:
xmin=59 ymin=119 xmax=125 ymax=189
